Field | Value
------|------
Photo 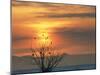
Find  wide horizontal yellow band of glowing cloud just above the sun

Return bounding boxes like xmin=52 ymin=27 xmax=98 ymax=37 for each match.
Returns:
xmin=27 ymin=20 xmax=65 ymax=32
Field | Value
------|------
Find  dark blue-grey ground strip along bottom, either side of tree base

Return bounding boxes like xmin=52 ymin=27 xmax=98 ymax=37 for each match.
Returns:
xmin=11 ymin=64 xmax=96 ymax=75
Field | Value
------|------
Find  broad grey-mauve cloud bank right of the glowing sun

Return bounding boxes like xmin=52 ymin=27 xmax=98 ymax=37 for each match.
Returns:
xmin=52 ymin=27 xmax=96 ymax=45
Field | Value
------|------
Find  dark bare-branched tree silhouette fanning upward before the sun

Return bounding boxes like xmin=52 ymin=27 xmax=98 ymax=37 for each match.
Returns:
xmin=31 ymin=32 xmax=63 ymax=72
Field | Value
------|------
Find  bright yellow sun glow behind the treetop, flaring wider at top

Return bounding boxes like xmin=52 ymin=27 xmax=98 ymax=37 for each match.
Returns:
xmin=30 ymin=22 xmax=54 ymax=46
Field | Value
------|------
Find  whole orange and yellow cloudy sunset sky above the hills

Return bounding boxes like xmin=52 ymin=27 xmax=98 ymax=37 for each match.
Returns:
xmin=12 ymin=0 xmax=96 ymax=56
